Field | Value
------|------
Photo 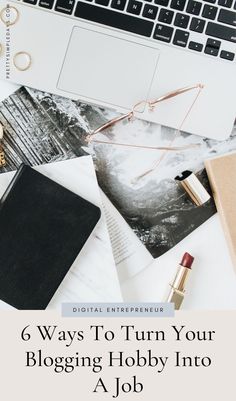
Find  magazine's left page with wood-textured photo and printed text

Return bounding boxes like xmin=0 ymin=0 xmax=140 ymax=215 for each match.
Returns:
xmin=0 ymin=88 xmax=152 ymax=281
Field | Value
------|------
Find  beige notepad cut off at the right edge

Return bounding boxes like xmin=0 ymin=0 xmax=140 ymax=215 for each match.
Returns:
xmin=205 ymin=152 xmax=236 ymax=269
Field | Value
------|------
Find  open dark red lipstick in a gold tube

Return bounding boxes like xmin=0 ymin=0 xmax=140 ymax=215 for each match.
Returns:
xmin=167 ymin=252 xmax=194 ymax=309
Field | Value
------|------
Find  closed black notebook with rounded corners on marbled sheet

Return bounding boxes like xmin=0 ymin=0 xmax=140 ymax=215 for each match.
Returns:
xmin=0 ymin=165 xmax=101 ymax=309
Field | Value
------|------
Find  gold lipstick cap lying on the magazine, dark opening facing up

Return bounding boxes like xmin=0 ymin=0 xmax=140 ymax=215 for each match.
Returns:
xmin=175 ymin=170 xmax=211 ymax=206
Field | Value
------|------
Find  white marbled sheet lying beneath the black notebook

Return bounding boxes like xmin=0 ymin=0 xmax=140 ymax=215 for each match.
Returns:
xmin=0 ymin=156 xmax=122 ymax=309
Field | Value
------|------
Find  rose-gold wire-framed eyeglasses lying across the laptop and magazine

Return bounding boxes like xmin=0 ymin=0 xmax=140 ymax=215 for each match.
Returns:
xmin=86 ymin=84 xmax=204 ymax=179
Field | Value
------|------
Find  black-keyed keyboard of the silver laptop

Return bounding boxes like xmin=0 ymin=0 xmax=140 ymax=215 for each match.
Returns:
xmin=23 ymin=0 xmax=236 ymax=61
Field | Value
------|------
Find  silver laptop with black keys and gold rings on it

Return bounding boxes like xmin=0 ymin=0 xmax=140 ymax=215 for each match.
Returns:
xmin=0 ymin=0 xmax=236 ymax=140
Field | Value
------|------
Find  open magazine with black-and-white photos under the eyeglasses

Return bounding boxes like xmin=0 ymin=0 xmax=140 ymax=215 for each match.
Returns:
xmin=0 ymin=87 xmax=236 ymax=281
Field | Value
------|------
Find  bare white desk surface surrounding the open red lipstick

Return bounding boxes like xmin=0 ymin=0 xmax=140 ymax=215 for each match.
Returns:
xmin=0 ymin=82 xmax=236 ymax=310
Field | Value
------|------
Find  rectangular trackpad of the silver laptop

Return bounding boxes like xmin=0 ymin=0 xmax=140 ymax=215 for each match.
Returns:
xmin=58 ymin=27 xmax=159 ymax=109
